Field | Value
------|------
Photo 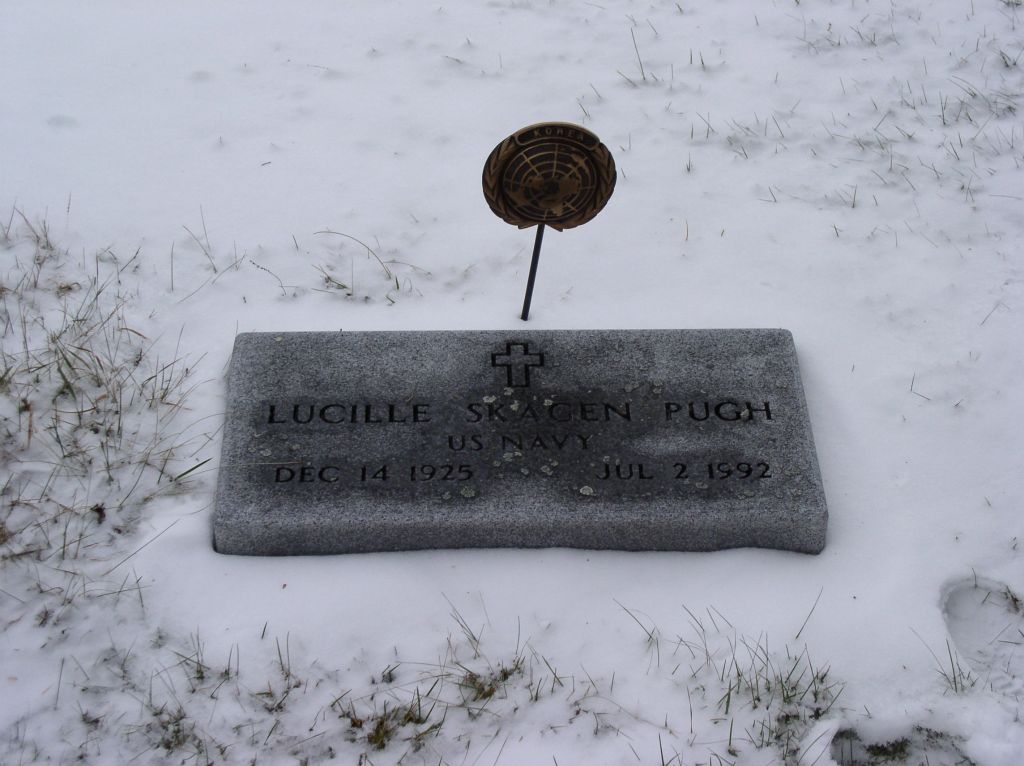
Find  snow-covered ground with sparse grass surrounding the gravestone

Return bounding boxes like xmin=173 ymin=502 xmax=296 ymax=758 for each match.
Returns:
xmin=0 ymin=0 xmax=1024 ymax=766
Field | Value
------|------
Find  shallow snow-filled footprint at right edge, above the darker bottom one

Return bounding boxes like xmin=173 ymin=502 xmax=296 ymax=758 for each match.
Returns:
xmin=942 ymin=578 xmax=1024 ymax=699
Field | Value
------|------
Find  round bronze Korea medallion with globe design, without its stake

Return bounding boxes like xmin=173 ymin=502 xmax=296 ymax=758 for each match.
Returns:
xmin=483 ymin=122 xmax=615 ymax=231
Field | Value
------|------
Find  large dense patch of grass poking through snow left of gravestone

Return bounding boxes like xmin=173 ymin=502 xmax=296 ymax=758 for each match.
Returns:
xmin=0 ymin=211 xmax=205 ymax=628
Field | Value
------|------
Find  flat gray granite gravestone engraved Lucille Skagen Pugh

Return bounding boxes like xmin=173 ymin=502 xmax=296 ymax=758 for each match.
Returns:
xmin=213 ymin=330 xmax=827 ymax=555
